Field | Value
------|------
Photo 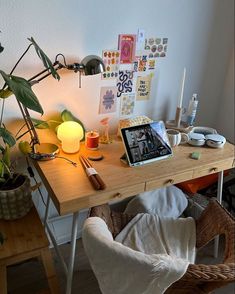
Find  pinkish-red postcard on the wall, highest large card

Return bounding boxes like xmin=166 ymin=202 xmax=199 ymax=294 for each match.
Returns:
xmin=118 ymin=35 xmax=136 ymax=64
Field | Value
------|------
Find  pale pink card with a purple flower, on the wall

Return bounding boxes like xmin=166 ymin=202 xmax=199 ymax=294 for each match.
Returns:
xmin=99 ymin=87 xmax=117 ymax=114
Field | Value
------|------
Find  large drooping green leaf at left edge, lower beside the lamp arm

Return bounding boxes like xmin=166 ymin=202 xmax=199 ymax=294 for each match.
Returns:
xmin=0 ymin=70 xmax=43 ymax=114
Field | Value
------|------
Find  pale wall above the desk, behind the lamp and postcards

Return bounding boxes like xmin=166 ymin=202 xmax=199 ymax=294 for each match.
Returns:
xmin=0 ymin=0 xmax=234 ymax=242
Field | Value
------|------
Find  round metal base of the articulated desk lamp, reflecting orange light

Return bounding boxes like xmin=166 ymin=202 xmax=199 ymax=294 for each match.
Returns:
xmin=29 ymin=143 xmax=59 ymax=160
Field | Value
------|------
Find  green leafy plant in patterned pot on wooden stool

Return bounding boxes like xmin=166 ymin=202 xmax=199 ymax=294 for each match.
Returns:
xmin=0 ymin=38 xmax=60 ymax=220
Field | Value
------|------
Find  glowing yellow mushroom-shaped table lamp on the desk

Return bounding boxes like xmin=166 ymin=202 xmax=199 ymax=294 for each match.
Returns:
xmin=57 ymin=121 xmax=84 ymax=153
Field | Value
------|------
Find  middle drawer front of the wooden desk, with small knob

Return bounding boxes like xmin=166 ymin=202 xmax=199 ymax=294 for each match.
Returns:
xmin=145 ymin=171 xmax=193 ymax=191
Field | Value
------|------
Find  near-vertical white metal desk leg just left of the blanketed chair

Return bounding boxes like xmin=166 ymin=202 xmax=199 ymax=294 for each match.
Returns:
xmin=66 ymin=212 xmax=79 ymax=294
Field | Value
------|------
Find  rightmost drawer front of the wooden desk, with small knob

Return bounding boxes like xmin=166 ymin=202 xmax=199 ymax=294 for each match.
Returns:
xmin=193 ymin=159 xmax=233 ymax=178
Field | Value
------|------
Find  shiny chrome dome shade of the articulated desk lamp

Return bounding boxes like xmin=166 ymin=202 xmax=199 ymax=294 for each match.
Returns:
xmin=81 ymin=55 xmax=105 ymax=76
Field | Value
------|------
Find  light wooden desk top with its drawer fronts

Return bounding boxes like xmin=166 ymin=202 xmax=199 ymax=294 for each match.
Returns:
xmin=34 ymin=139 xmax=234 ymax=215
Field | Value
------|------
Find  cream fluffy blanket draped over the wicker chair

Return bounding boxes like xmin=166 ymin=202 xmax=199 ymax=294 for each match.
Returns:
xmin=83 ymin=214 xmax=196 ymax=294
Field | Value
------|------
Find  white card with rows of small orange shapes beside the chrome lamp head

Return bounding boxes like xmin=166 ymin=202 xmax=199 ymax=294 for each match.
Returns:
xmin=102 ymin=50 xmax=120 ymax=79
